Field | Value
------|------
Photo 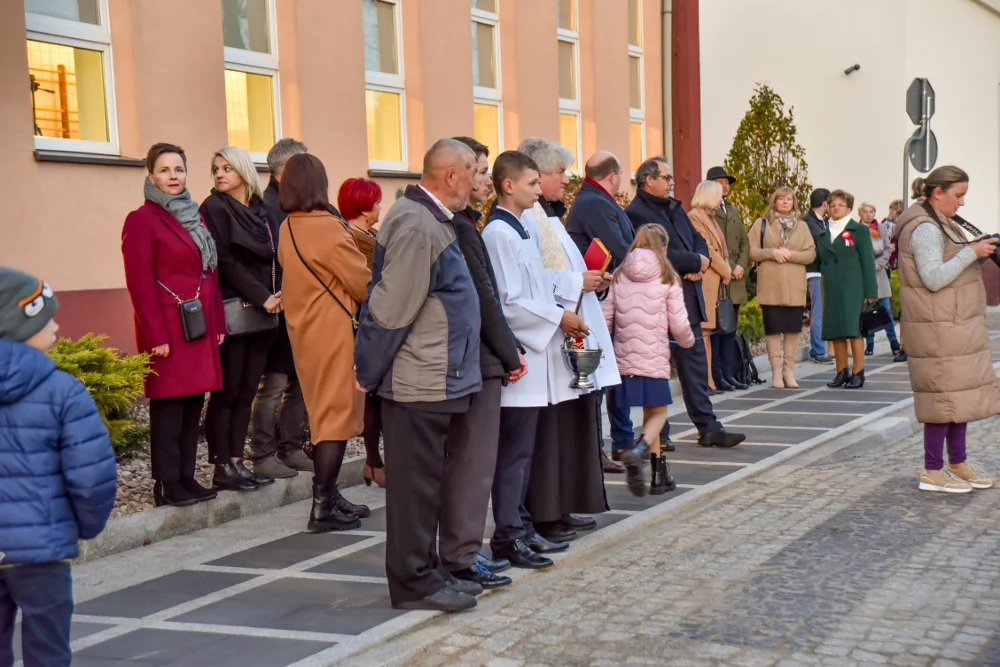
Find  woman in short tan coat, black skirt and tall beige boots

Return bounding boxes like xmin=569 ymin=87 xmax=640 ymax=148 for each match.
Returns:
xmin=750 ymin=188 xmax=816 ymax=389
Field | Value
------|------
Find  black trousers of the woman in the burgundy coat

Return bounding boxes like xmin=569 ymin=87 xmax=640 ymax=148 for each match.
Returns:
xmin=149 ymin=394 xmax=205 ymax=484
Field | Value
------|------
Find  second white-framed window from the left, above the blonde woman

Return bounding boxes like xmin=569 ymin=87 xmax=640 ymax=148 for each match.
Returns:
xmin=222 ymin=0 xmax=281 ymax=162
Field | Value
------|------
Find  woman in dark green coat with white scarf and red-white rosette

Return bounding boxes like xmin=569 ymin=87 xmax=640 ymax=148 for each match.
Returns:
xmin=817 ymin=190 xmax=878 ymax=389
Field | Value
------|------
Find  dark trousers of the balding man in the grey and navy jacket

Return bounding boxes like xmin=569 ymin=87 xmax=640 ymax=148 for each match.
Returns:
xmin=382 ymin=400 xmax=469 ymax=603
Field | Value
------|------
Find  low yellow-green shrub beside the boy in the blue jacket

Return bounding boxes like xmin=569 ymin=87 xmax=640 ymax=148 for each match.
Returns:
xmin=49 ymin=334 xmax=152 ymax=454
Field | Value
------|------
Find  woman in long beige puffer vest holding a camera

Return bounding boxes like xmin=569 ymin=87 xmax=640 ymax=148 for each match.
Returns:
xmin=896 ymin=167 xmax=1000 ymax=493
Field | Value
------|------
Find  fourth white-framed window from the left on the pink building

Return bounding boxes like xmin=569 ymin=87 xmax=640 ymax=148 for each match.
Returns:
xmin=471 ymin=0 xmax=503 ymax=164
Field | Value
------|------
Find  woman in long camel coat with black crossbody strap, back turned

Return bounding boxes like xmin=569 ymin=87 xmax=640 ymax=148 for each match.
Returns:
xmin=278 ymin=153 xmax=371 ymax=533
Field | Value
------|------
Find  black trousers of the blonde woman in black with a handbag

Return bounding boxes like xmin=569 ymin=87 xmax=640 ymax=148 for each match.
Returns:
xmin=205 ymin=333 xmax=275 ymax=464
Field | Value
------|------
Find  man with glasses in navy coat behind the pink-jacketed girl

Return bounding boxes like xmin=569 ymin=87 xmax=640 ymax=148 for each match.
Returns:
xmin=625 ymin=157 xmax=746 ymax=451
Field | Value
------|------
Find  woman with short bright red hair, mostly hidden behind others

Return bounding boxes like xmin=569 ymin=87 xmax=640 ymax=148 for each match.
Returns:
xmin=337 ymin=178 xmax=385 ymax=488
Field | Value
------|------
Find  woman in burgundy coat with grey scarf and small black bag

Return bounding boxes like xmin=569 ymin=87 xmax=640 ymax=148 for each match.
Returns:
xmin=122 ymin=144 xmax=226 ymax=505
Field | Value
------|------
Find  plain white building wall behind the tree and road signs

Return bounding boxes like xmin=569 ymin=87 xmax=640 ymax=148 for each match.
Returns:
xmin=700 ymin=0 xmax=1000 ymax=231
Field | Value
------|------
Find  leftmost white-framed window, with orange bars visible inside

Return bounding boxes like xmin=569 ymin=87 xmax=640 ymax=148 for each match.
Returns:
xmin=24 ymin=0 xmax=118 ymax=155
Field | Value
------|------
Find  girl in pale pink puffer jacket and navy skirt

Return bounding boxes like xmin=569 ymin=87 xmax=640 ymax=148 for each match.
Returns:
xmin=604 ymin=225 xmax=695 ymax=496
